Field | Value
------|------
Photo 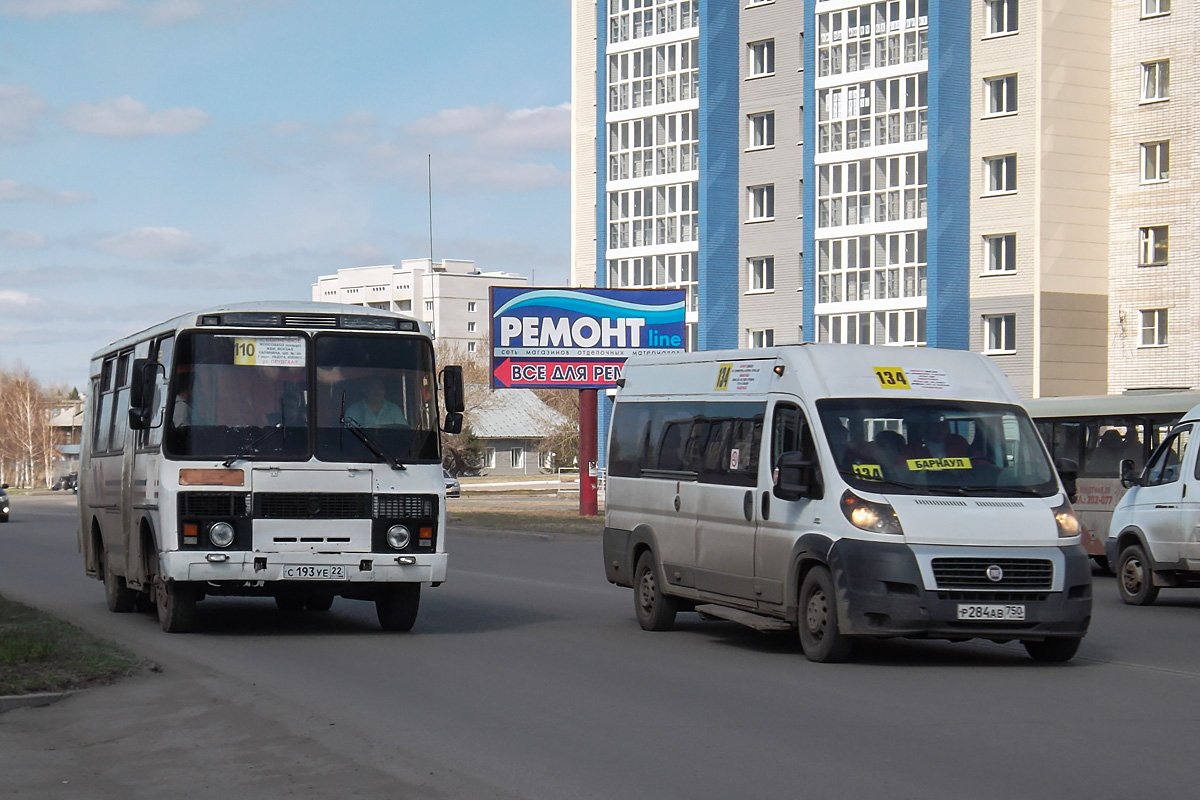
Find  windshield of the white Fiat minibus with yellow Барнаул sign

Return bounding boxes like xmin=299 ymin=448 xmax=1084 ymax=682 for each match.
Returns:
xmin=817 ymin=398 xmax=1058 ymax=497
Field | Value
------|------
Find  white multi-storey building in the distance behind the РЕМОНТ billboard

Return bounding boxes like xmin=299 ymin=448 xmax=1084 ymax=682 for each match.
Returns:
xmin=312 ymin=258 xmax=529 ymax=353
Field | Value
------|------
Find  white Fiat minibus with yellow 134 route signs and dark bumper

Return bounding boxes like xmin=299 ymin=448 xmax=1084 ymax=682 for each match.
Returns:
xmin=604 ymin=344 xmax=1092 ymax=661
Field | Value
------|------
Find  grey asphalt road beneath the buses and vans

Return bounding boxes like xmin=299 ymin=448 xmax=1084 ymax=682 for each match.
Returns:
xmin=0 ymin=497 xmax=1200 ymax=800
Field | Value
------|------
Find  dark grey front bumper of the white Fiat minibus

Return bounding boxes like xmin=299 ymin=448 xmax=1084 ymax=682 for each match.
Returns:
xmin=829 ymin=539 xmax=1092 ymax=640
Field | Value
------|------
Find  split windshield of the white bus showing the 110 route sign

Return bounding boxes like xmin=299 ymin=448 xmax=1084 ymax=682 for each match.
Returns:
xmin=164 ymin=331 xmax=439 ymax=463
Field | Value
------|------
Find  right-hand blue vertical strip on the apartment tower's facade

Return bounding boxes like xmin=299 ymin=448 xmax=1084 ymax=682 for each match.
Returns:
xmin=925 ymin=2 xmax=971 ymax=350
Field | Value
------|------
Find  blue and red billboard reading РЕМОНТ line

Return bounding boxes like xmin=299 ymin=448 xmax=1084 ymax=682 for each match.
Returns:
xmin=492 ymin=287 xmax=688 ymax=389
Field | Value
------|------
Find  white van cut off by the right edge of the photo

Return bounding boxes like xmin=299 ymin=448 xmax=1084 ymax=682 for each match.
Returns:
xmin=1105 ymin=405 xmax=1200 ymax=606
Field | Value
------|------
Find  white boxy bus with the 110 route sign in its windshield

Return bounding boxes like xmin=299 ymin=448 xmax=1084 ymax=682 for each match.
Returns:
xmin=79 ymin=302 xmax=462 ymax=632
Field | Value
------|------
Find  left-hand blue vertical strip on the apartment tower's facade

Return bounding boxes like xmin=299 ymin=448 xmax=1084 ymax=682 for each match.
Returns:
xmin=696 ymin=2 xmax=742 ymax=350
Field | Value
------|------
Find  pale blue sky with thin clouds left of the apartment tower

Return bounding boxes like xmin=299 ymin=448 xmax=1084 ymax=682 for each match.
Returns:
xmin=0 ymin=0 xmax=570 ymax=391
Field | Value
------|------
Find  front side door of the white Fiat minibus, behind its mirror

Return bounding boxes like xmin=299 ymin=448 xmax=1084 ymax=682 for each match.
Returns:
xmin=754 ymin=399 xmax=817 ymax=609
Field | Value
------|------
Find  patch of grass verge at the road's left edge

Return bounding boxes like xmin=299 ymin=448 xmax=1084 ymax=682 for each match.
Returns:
xmin=0 ymin=595 xmax=138 ymax=696
